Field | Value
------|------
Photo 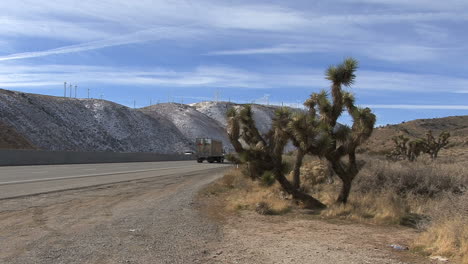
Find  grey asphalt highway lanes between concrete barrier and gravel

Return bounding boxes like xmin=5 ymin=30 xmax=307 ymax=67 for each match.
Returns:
xmin=0 ymin=161 xmax=229 ymax=199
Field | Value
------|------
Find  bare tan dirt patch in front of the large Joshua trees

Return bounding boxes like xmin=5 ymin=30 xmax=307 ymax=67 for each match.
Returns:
xmin=199 ymin=184 xmax=437 ymax=264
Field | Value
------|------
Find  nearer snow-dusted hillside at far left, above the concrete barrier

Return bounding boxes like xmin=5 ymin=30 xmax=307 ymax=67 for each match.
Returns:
xmin=0 ymin=90 xmax=191 ymax=153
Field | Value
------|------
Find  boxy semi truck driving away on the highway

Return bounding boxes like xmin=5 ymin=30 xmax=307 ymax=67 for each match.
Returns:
xmin=196 ymin=138 xmax=224 ymax=163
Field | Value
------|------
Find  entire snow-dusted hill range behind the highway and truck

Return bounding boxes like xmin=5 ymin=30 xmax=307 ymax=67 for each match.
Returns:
xmin=0 ymin=89 xmax=286 ymax=153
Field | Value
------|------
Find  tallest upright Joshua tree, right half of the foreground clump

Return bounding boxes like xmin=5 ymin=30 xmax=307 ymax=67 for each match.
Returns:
xmin=304 ymin=58 xmax=376 ymax=203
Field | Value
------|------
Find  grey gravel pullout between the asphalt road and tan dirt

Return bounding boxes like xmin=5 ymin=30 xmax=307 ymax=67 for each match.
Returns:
xmin=0 ymin=169 xmax=227 ymax=264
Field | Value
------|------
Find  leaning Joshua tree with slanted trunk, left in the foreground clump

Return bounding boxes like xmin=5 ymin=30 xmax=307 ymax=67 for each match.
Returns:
xmin=228 ymin=106 xmax=325 ymax=208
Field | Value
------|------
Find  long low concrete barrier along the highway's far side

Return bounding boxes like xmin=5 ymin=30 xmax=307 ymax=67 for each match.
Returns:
xmin=0 ymin=149 xmax=195 ymax=166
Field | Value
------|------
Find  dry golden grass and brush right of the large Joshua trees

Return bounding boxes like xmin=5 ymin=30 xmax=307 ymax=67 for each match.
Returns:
xmin=312 ymin=157 xmax=468 ymax=264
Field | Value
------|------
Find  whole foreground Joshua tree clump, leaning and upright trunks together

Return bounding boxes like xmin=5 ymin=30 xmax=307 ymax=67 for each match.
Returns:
xmin=228 ymin=58 xmax=375 ymax=207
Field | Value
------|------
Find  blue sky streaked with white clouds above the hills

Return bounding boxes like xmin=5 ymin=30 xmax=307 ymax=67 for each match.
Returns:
xmin=0 ymin=0 xmax=468 ymax=125
